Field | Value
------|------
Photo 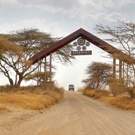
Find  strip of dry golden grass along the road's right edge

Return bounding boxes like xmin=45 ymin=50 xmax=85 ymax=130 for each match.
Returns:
xmin=82 ymin=89 xmax=135 ymax=110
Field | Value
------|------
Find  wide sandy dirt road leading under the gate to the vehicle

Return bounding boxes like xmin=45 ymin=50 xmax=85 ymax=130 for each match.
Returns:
xmin=0 ymin=92 xmax=135 ymax=135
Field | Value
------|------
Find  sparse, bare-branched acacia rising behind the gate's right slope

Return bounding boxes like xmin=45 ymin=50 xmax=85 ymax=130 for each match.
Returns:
xmin=96 ymin=22 xmax=135 ymax=86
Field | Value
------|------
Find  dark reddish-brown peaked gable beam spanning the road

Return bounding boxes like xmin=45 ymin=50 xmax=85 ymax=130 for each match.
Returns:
xmin=29 ymin=29 xmax=135 ymax=64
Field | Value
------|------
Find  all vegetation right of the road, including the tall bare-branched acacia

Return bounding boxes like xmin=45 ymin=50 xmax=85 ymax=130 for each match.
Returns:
xmin=82 ymin=22 xmax=135 ymax=110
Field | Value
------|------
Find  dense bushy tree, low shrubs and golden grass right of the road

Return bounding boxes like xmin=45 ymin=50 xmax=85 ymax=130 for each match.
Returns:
xmin=81 ymin=59 xmax=135 ymax=110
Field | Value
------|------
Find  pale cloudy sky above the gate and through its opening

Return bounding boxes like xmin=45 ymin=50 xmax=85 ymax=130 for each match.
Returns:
xmin=0 ymin=0 xmax=135 ymax=88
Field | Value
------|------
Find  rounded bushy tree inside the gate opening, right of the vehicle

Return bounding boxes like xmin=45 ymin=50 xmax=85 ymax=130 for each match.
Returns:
xmin=83 ymin=62 xmax=112 ymax=89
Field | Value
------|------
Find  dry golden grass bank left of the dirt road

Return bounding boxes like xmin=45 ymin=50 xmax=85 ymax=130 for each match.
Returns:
xmin=0 ymin=87 xmax=64 ymax=111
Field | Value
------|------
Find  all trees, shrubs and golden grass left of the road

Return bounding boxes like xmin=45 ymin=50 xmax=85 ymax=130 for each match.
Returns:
xmin=0 ymin=29 xmax=74 ymax=112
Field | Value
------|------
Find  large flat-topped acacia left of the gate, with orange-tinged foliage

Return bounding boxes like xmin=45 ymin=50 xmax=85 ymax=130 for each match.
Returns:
xmin=0 ymin=29 xmax=73 ymax=86
